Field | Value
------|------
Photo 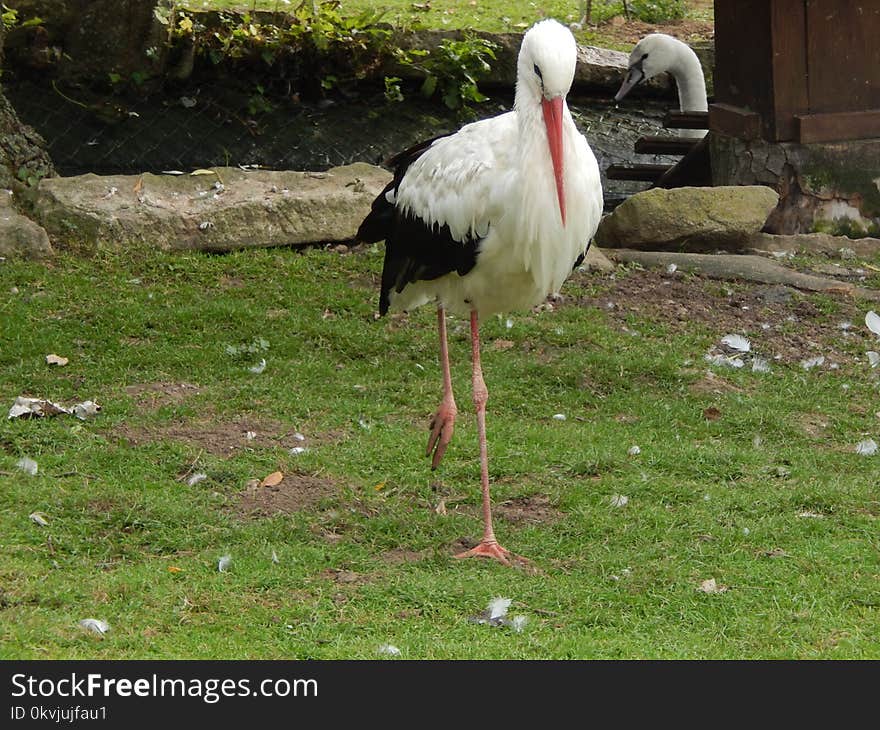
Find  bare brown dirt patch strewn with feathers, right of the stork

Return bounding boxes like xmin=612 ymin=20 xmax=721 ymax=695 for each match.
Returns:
xmin=578 ymin=269 xmax=872 ymax=366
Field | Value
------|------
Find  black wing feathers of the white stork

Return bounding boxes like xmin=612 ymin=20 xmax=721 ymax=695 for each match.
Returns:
xmin=357 ymin=135 xmax=483 ymax=314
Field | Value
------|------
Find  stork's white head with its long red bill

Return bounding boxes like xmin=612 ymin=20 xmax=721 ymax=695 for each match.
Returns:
xmin=516 ymin=19 xmax=577 ymax=225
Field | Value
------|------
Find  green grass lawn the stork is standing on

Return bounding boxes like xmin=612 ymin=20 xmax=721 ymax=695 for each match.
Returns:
xmin=0 ymin=246 xmax=880 ymax=659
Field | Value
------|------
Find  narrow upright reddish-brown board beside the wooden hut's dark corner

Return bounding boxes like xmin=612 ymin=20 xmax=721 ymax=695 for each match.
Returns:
xmin=768 ymin=0 xmax=808 ymax=140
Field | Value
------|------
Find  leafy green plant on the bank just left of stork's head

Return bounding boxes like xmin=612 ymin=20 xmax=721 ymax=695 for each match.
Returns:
xmin=397 ymin=34 xmax=497 ymax=109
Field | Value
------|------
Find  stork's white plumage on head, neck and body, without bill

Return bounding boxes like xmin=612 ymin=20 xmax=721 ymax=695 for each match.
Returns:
xmin=387 ymin=21 xmax=603 ymax=316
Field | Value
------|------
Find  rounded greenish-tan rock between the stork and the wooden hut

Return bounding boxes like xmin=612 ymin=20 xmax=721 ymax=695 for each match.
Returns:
xmin=596 ymin=185 xmax=779 ymax=251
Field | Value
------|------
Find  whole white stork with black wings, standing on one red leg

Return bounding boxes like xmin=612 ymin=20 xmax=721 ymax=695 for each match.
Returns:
xmin=357 ymin=20 xmax=602 ymax=564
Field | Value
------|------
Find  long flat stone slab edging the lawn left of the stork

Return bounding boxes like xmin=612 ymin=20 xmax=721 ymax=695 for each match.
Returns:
xmin=34 ymin=163 xmax=391 ymax=251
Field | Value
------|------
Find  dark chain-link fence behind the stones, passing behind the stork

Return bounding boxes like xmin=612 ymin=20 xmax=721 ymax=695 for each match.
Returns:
xmin=6 ymin=81 xmax=675 ymax=203
